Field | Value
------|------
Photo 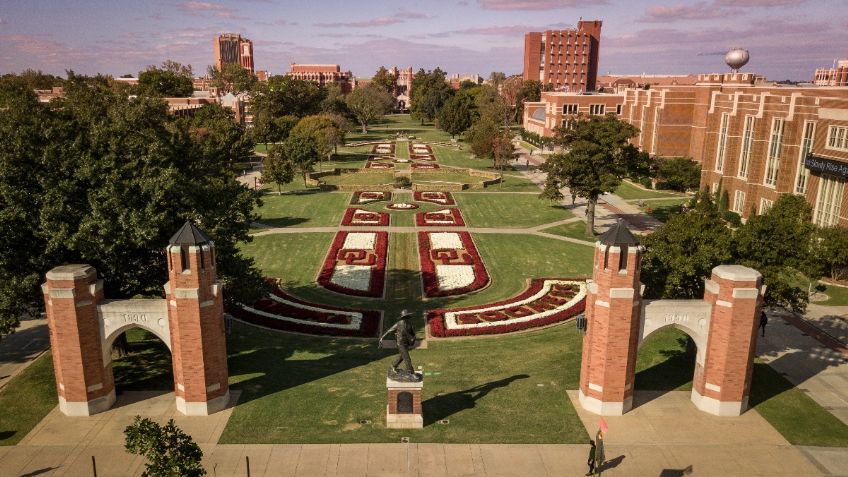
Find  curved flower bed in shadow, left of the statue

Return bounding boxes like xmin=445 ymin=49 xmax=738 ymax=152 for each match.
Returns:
xmin=233 ymin=280 xmax=380 ymax=337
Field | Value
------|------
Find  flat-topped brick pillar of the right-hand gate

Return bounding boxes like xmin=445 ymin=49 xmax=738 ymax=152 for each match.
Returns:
xmin=692 ymin=265 xmax=765 ymax=416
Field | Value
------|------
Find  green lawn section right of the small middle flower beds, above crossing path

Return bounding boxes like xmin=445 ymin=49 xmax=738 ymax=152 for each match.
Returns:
xmin=454 ymin=192 xmax=573 ymax=228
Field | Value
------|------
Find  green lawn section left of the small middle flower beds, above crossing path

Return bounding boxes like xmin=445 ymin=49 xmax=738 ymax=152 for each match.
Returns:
xmin=257 ymin=192 xmax=350 ymax=227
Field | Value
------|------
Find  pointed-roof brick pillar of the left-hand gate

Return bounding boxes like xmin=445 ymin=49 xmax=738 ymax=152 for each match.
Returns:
xmin=165 ymin=222 xmax=229 ymax=416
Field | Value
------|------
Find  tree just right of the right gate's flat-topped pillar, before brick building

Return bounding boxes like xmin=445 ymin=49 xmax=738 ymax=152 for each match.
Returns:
xmin=736 ymin=194 xmax=820 ymax=312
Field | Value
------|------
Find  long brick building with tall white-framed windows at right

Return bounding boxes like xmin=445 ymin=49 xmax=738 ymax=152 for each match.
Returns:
xmin=524 ymin=73 xmax=848 ymax=226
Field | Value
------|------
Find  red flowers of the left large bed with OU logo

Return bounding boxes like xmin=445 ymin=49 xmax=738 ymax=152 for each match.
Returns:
xmin=318 ymin=232 xmax=389 ymax=298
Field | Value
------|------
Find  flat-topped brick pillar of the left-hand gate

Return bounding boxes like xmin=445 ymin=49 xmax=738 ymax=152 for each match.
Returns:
xmin=41 ymin=265 xmax=115 ymax=416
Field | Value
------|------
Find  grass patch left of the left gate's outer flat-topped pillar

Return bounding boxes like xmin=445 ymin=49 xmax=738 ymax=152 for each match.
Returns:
xmin=0 ymin=352 xmax=58 ymax=446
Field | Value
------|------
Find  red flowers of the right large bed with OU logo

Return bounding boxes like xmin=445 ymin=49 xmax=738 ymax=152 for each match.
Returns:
xmin=418 ymin=232 xmax=489 ymax=297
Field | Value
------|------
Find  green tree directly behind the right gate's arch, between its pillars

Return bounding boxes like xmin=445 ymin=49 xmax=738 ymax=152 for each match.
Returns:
xmin=641 ymin=193 xmax=734 ymax=299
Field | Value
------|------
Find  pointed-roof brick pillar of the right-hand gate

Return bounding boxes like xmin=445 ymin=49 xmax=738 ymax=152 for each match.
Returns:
xmin=579 ymin=221 xmax=643 ymax=416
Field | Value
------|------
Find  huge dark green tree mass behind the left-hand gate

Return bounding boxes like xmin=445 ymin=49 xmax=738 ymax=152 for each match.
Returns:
xmin=0 ymin=74 xmax=263 ymax=338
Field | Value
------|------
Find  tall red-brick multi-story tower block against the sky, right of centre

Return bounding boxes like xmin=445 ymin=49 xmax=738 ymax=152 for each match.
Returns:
xmin=524 ymin=20 xmax=602 ymax=93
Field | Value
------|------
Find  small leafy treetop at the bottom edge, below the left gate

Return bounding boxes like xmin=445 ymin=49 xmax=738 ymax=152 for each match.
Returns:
xmin=124 ymin=416 xmax=206 ymax=477
